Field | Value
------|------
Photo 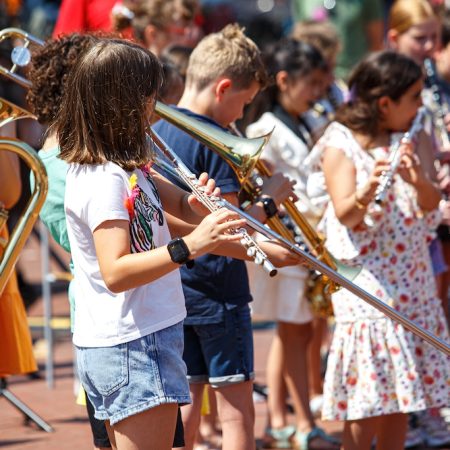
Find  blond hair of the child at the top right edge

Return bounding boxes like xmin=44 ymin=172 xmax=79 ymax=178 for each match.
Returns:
xmin=388 ymin=0 xmax=439 ymax=34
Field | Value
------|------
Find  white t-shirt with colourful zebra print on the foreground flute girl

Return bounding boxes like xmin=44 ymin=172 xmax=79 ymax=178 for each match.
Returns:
xmin=65 ymin=163 xmax=186 ymax=347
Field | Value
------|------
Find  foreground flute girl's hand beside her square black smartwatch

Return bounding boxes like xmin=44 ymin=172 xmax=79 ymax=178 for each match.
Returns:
xmin=183 ymin=208 xmax=246 ymax=258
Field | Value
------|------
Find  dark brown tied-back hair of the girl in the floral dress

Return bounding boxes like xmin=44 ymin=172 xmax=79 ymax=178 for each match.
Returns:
xmin=336 ymin=51 xmax=423 ymax=137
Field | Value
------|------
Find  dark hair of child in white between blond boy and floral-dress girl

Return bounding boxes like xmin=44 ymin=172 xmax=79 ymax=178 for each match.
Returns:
xmin=239 ymin=38 xmax=328 ymax=126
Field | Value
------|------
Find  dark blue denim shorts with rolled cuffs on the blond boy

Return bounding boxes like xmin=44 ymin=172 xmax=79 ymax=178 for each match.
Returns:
xmin=183 ymin=305 xmax=254 ymax=388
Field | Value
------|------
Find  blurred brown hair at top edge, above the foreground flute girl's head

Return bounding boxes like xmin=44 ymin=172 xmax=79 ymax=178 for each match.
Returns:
xmin=112 ymin=0 xmax=199 ymax=41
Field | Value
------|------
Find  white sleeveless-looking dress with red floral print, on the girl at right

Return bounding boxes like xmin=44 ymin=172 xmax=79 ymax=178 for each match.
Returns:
xmin=307 ymin=122 xmax=450 ymax=420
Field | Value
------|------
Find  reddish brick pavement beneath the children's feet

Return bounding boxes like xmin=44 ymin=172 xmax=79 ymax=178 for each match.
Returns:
xmin=0 ymin=230 xmax=448 ymax=450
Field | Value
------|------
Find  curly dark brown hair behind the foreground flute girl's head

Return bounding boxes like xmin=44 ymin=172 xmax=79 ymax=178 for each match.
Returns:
xmin=27 ymin=33 xmax=97 ymax=125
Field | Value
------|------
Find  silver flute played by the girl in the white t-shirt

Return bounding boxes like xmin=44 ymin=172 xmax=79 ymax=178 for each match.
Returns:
xmin=150 ymin=130 xmax=278 ymax=277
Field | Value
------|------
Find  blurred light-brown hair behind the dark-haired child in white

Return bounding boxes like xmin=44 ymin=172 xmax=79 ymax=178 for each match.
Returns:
xmin=291 ymin=20 xmax=341 ymax=61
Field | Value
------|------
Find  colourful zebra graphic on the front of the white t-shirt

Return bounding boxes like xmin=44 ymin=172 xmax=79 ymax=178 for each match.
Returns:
xmin=130 ymin=174 xmax=164 ymax=253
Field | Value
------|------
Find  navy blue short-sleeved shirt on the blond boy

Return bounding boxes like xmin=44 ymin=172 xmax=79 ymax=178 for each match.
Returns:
xmin=153 ymin=108 xmax=251 ymax=325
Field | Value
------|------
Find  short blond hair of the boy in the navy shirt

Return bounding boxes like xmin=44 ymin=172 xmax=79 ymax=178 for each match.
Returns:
xmin=186 ymin=24 xmax=267 ymax=90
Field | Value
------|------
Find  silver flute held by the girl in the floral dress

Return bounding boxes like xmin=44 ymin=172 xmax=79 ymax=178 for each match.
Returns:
xmin=375 ymin=106 xmax=425 ymax=205
